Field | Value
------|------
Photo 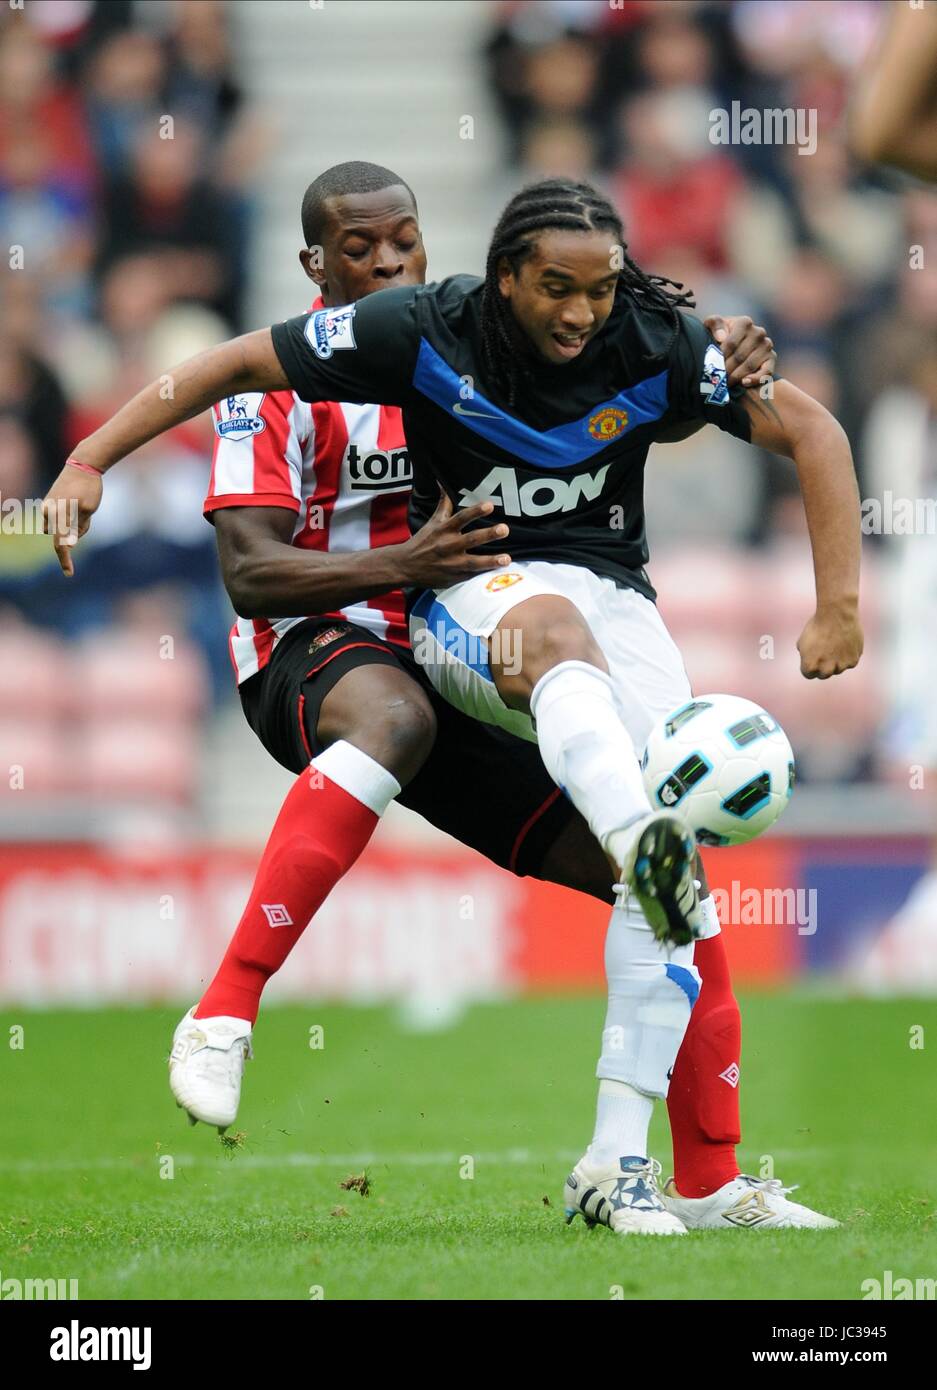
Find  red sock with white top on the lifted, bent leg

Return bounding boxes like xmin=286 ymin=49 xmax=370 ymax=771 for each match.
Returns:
xmin=195 ymin=744 xmax=389 ymax=1023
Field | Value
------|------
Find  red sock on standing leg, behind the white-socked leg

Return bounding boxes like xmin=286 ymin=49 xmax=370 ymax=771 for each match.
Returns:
xmin=667 ymin=934 xmax=742 ymax=1197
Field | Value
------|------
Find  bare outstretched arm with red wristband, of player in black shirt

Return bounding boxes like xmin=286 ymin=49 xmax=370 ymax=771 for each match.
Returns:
xmin=43 ymin=328 xmax=289 ymax=574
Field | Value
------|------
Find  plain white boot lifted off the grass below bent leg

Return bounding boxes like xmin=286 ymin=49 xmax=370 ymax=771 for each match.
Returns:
xmin=170 ymin=1005 xmax=253 ymax=1133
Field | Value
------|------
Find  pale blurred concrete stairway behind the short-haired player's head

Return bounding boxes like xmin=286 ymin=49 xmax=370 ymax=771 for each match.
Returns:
xmin=234 ymin=0 xmax=502 ymax=325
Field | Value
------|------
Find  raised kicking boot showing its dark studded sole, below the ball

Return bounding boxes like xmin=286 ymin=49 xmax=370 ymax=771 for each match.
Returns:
xmin=609 ymin=810 xmax=703 ymax=947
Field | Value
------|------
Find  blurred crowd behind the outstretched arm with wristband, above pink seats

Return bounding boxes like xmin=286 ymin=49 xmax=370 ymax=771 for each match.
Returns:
xmin=0 ymin=0 xmax=266 ymax=695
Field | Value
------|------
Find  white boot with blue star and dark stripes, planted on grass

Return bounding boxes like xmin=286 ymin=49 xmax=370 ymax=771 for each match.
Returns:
xmin=563 ymin=1156 xmax=687 ymax=1236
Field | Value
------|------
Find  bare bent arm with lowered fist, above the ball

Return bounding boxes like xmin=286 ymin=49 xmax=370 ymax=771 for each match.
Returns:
xmin=744 ymin=381 xmax=862 ymax=680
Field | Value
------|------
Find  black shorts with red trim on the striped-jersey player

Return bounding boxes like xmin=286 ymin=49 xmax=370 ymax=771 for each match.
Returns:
xmin=241 ymin=617 xmax=576 ymax=877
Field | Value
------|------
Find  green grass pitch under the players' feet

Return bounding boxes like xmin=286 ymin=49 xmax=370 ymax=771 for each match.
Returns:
xmin=0 ymin=994 xmax=937 ymax=1300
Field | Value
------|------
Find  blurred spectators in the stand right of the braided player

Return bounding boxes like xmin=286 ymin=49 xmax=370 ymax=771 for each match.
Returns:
xmin=485 ymin=0 xmax=937 ymax=778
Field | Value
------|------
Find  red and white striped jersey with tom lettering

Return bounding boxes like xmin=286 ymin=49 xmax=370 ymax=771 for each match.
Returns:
xmin=204 ymin=299 xmax=412 ymax=684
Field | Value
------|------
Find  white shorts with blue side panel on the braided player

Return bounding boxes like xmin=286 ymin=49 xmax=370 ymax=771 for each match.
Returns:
xmin=410 ymin=560 xmax=691 ymax=756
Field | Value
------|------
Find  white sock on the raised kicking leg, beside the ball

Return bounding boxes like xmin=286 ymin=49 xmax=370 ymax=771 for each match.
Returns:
xmin=530 ymin=662 xmax=651 ymax=851
